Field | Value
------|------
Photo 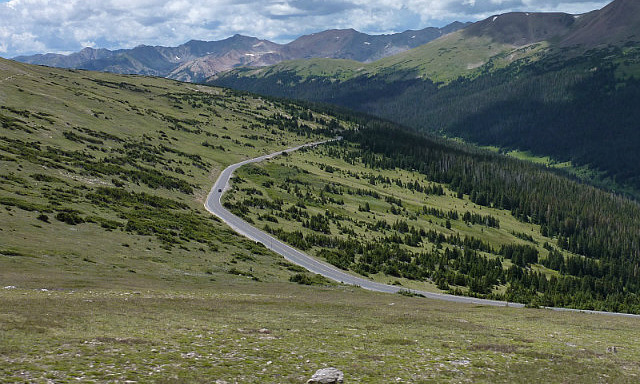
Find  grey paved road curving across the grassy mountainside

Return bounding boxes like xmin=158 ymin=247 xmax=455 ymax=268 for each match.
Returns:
xmin=204 ymin=138 xmax=640 ymax=318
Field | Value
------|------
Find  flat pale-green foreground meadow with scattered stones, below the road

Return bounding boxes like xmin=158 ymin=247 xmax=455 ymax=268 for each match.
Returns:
xmin=0 ymin=279 xmax=640 ymax=383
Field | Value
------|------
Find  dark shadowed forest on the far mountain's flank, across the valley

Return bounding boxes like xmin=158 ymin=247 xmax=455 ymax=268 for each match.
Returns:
xmin=212 ymin=47 xmax=640 ymax=196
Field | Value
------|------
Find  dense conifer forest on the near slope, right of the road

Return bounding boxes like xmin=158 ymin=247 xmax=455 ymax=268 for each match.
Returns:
xmin=348 ymin=121 xmax=640 ymax=307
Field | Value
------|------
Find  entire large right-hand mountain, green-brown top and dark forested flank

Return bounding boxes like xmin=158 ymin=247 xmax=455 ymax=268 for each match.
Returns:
xmin=210 ymin=0 xmax=640 ymax=198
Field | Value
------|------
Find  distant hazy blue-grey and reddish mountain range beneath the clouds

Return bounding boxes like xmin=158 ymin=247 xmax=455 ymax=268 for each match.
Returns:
xmin=14 ymin=22 xmax=469 ymax=82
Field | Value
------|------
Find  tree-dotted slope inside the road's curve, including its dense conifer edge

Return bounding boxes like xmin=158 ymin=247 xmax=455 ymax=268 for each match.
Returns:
xmin=226 ymin=110 xmax=640 ymax=312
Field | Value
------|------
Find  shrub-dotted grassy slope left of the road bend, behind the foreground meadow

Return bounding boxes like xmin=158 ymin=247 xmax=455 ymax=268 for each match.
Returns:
xmin=0 ymin=57 xmax=332 ymax=288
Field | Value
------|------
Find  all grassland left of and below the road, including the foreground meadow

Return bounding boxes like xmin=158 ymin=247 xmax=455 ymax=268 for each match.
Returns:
xmin=0 ymin=61 xmax=640 ymax=383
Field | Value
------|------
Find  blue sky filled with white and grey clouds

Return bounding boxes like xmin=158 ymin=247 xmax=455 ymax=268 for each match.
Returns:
xmin=0 ymin=0 xmax=611 ymax=58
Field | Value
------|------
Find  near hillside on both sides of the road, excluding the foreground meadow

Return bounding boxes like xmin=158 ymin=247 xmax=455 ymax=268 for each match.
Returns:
xmin=0 ymin=57 xmax=640 ymax=312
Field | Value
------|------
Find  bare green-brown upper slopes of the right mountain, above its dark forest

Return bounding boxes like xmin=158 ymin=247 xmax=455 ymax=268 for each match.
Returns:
xmin=214 ymin=0 xmax=640 ymax=82
